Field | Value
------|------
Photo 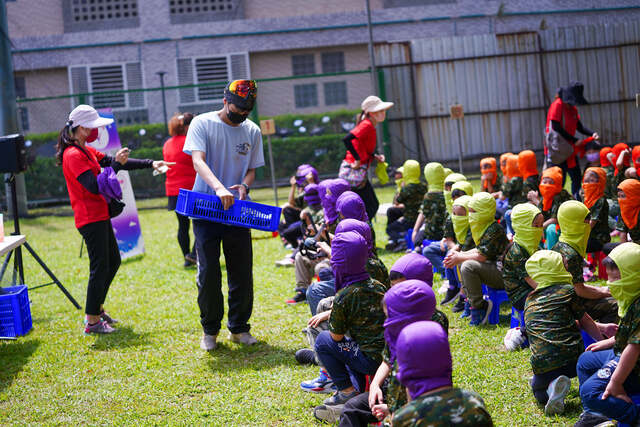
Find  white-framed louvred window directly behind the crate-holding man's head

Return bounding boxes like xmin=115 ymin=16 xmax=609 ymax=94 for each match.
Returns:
xmin=177 ymin=53 xmax=251 ymax=105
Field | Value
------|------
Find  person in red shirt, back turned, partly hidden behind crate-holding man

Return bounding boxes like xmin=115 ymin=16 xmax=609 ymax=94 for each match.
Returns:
xmin=162 ymin=113 xmax=196 ymax=267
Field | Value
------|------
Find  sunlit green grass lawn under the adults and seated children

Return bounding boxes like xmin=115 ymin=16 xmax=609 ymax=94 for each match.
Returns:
xmin=0 ymin=187 xmax=592 ymax=426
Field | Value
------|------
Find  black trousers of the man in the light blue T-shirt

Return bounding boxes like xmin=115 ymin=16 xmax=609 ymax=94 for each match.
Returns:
xmin=193 ymin=219 xmax=253 ymax=335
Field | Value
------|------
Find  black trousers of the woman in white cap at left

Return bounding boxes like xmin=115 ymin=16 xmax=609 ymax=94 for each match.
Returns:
xmin=78 ymin=220 xmax=120 ymax=316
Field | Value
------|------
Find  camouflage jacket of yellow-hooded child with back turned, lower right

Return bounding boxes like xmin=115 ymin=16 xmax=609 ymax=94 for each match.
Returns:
xmin=524 ymin=283 xmax=585 ymax=375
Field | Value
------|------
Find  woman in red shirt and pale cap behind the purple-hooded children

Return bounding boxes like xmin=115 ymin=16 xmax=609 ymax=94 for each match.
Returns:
xmin=340 ymin=95 xmax=393 ymax=218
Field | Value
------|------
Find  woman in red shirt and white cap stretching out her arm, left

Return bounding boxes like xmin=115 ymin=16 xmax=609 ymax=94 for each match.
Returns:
xmin=56 ymin=105 xmax=169 ymax=334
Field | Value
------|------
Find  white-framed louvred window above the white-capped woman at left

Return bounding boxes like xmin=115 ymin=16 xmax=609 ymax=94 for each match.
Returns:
xmin=69 ymin=62 xmax=145 ymax=109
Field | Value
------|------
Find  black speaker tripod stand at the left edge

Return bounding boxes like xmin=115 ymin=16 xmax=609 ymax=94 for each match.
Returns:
xmin=0 ymin=174 xmax=81 ymax=310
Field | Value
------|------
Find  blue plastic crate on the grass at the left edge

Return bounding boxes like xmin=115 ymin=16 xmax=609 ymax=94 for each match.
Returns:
xmin=0 ymin=285 xmax=32 ymax=337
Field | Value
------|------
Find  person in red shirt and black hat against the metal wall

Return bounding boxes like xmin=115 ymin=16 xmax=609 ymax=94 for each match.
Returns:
xmin=545 ymin=82 xmax=599 ymax=200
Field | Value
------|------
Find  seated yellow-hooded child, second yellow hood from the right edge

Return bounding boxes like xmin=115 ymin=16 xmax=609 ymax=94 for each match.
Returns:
xmin=552 ymin=200 xmax=618 ymax=323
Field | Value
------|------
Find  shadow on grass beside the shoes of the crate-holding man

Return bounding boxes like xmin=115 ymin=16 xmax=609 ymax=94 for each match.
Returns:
xmin=207 ymin=341 xmax=295 ymax=372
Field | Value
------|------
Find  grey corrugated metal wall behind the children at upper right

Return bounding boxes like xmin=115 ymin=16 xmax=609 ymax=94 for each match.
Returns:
xmin=376 ymin=22 xmax=640 ymax=172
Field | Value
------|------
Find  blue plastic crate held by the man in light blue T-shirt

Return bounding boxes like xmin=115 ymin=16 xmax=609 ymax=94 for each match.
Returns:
xmin=176 ymin=188 xmax=282 ymax=231
